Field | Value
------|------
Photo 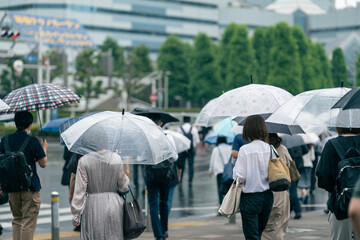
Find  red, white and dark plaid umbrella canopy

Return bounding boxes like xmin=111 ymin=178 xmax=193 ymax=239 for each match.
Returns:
xmin=0 ymin=83 xmax=80 ymax=114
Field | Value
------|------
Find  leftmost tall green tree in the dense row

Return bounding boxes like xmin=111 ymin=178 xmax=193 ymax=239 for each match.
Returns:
xmin=157 ymin=35 xmax=190 ymax=107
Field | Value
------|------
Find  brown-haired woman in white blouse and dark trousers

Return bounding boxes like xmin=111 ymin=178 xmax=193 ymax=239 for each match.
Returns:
xmin=233 ymin=115 xmax=274 ymax=240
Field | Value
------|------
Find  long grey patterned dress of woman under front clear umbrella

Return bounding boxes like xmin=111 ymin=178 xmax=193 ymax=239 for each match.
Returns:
xmin=71 ymin=151 xmax=129 ymax=240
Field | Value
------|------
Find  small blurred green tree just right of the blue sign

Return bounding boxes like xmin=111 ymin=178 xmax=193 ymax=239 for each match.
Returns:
xmin=99 ymin=37 xmax=125 ymax=76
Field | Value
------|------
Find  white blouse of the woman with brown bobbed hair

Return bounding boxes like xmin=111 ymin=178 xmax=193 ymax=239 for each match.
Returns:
xmin=233 ymin=140 xmax=275 ymax=193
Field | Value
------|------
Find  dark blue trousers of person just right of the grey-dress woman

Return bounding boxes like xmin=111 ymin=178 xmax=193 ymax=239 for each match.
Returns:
xmin=147 ymin=180 xmax=170 ymax=238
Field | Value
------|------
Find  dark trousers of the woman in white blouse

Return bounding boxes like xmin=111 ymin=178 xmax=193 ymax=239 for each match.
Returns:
xmin=240 ymin=190 xmax=274 ymax=240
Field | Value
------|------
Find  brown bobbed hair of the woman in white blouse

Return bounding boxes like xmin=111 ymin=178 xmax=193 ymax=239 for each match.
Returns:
xmin=243 ymin=115 xmax=268 ymax=142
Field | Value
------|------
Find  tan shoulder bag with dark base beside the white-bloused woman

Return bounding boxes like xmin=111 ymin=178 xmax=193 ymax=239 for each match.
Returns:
xmin=268 ymin=145 xmax=291 ymax=192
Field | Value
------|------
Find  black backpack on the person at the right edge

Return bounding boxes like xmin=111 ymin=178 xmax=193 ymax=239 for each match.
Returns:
xmin=329 ymin=139 xmax=360 ymax=220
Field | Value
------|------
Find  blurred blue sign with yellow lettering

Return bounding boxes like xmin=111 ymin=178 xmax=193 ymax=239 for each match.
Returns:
xmin=9 ymin=13 xmax=96 ymax=48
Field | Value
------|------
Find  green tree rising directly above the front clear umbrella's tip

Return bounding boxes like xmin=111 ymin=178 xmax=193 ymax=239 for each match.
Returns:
xmin=122 ymin=45 xmax=153 ymax=110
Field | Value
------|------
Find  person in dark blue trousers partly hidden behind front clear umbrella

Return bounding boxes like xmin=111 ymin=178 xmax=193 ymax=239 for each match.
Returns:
xmin=144 ymin=113 xmax=178 ymax=240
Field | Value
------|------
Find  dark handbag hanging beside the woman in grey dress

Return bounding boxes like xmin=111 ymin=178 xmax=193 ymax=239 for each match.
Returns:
xmin=121 ymin=186 xmax=146 ymax=239
